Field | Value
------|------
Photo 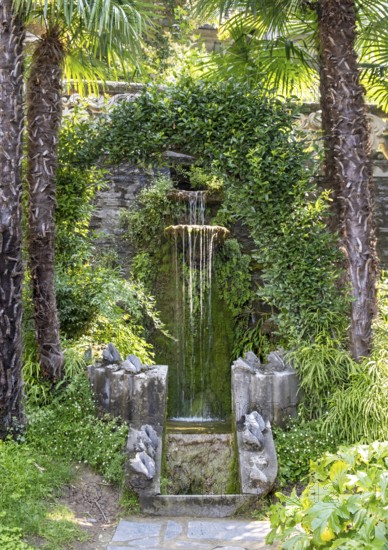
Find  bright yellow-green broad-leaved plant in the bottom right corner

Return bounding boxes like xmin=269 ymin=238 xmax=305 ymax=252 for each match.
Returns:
xmin=267 ymin=442 xmax=388 ymax=550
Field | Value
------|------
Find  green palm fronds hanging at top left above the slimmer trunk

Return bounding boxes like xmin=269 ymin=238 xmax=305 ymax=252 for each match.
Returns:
xmin=15 ymin=0 xmax=158 ymax=84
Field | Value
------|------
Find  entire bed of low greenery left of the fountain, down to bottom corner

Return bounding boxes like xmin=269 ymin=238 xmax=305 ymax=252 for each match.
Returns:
xmin=0 ymin=372 xmax=133 ymax=550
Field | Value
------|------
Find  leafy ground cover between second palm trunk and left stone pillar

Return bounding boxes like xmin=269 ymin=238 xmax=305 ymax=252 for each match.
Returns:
xmin=27 ymin=372 xmax=128 ymax=482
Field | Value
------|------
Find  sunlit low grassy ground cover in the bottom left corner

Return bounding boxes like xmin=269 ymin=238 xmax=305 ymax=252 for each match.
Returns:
xmin=0 ymin=440 xmax=87 ymax=550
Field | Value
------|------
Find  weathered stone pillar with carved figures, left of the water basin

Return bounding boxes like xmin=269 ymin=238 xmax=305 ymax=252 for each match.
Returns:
xmin=88 ymin=350 xmax=168 ymax=496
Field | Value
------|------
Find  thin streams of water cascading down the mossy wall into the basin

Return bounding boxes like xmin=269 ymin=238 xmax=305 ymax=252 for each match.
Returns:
xmin=166 ymin=191 xmax=228 ymax=421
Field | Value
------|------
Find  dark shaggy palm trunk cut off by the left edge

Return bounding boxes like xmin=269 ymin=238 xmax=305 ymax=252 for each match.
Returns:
xmin=0 ymin=0 xmax=24 ymax=439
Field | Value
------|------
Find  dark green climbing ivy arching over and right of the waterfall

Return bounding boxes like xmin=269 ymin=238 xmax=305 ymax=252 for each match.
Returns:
xmin=101 ymin=80 xmax=348 ymax=354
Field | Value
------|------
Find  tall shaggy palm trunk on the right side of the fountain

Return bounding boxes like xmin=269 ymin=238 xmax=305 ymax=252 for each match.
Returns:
xmin=318 ymin=0 xmax=378 ymax=361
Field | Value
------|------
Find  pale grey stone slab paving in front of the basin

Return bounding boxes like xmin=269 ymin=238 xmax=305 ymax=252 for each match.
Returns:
xmin=107 ymin=518 xmax=274 ymax=550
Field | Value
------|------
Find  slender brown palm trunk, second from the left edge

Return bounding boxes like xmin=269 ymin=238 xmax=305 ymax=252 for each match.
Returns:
xmin=27 ymin=28 xmax=64 ymax=383
